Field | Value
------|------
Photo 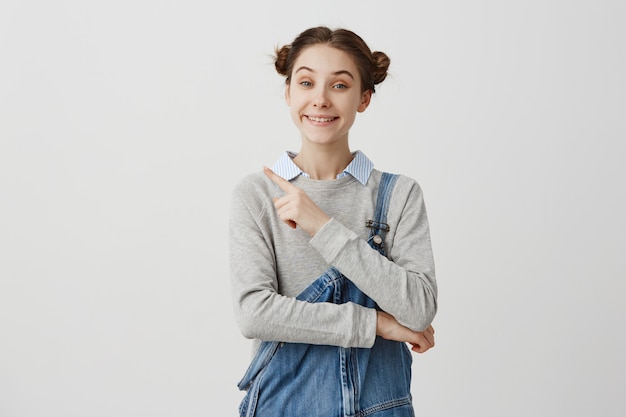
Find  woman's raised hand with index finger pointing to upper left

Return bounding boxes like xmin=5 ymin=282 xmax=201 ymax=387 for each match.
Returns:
xmin=263 ymin=167 xmax=330 ymax=237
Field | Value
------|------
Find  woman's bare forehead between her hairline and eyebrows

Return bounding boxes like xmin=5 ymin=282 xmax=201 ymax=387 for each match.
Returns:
xmin=293 ymin=44 xmax=359 ymax=77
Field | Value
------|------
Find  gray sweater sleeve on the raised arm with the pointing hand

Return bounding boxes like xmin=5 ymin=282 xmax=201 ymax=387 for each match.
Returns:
xmin=310 ymin=177 xmax=437 ymax=331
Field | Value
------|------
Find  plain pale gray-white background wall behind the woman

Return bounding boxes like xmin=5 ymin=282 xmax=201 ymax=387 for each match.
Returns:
xmin=0 ymin=0 xmax=626 ymax=417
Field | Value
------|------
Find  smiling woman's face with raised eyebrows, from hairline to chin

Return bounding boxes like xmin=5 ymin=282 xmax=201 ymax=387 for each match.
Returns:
xmin=285 ymin=44 xmax=372 ymax=145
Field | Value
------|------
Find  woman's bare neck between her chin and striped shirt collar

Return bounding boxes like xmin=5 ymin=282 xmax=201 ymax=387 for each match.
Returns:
xmin=293 ymin=143 xmax=352 ymax=180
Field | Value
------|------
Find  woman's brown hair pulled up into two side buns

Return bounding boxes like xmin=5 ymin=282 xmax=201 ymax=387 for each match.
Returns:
xmin=274 ymin=26 xmax=391 ymax=93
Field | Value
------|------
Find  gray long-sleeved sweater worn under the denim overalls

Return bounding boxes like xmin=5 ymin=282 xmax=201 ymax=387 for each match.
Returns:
xmin=230 ymin=170 xmax=437 ymax=349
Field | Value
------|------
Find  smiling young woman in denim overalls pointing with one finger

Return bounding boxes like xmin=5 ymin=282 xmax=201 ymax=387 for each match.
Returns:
xmin=230 ymin=27 xmax=437 ymax=417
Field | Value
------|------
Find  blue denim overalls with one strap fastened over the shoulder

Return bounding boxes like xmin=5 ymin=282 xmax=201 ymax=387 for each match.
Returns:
xmin=238 ymin=173 xmax=414 ymax=417
